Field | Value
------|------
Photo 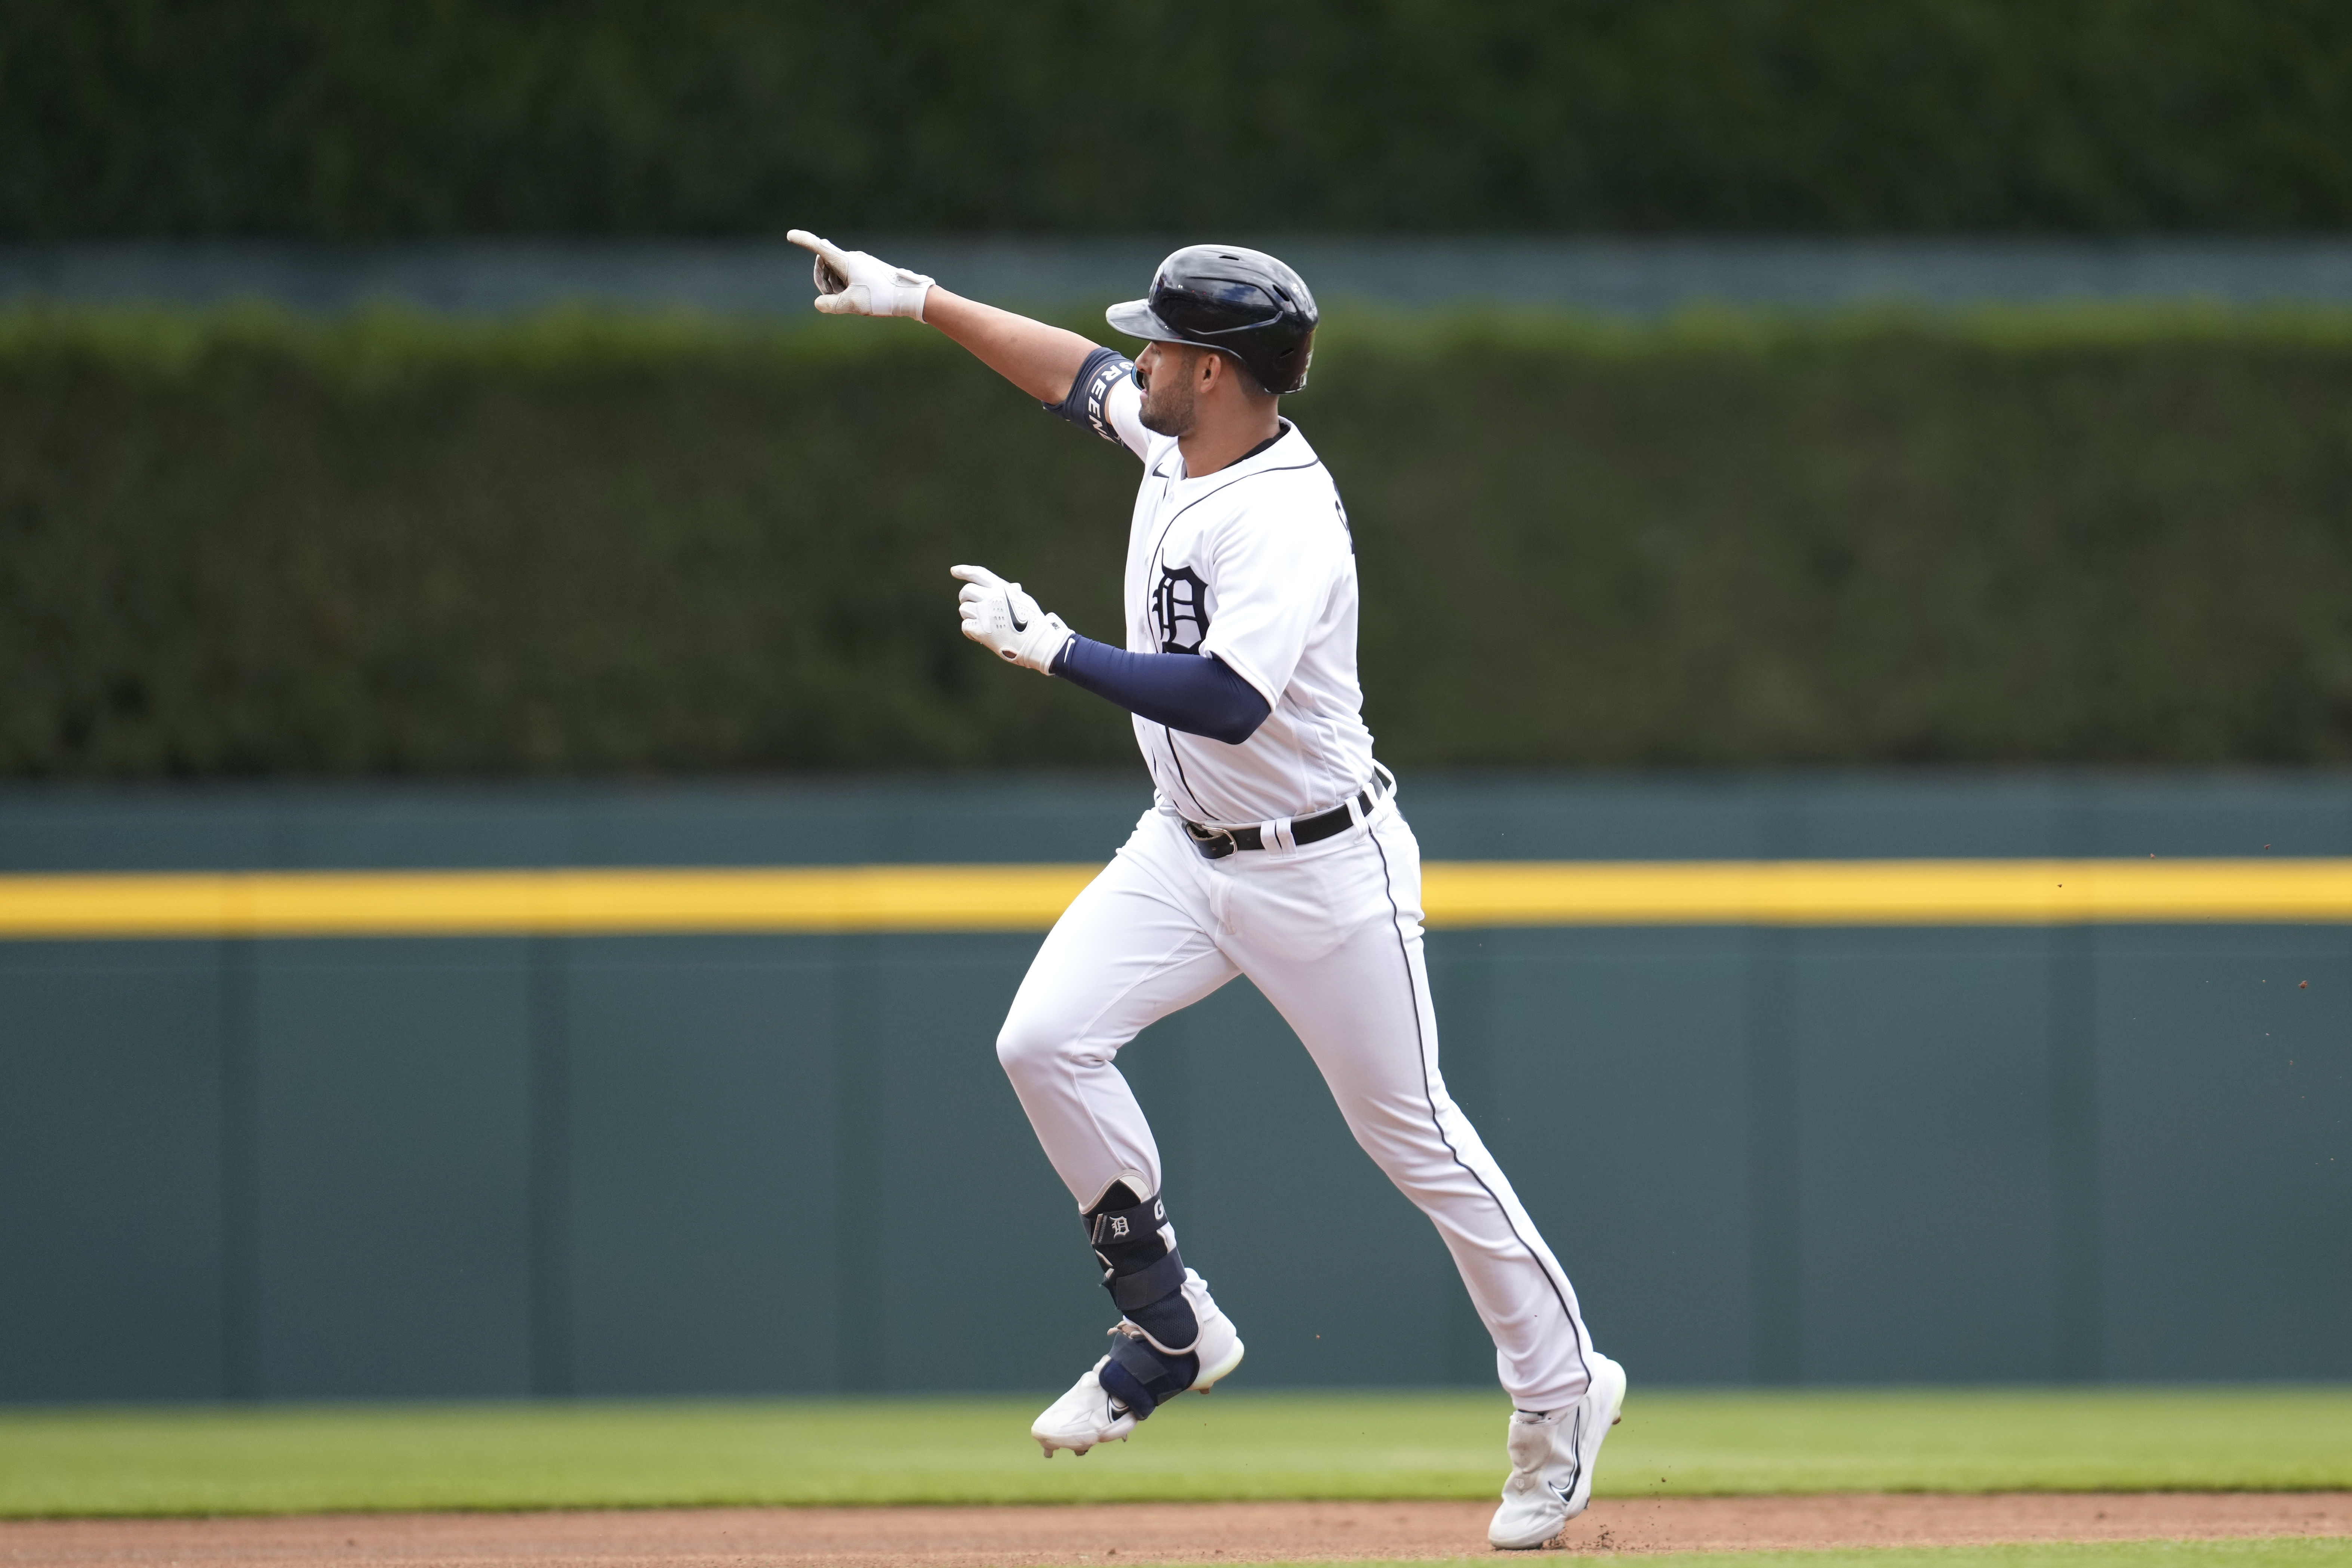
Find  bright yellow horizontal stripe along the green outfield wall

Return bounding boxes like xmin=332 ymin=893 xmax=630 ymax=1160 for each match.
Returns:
xmin=0 ymin=858 xmax=2352 ymax=940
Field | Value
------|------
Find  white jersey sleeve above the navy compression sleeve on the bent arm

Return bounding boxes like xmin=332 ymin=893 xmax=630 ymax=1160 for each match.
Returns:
xmin=1200 ymin=487 xmax=1350 ymax=708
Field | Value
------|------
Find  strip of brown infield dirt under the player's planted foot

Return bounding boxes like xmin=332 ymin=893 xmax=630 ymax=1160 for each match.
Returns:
xmin=0 ymin=1493 xmax=2352 ymax=1568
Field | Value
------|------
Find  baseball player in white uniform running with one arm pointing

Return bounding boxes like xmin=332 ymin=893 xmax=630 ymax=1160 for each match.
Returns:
xmin=790 ymin=228 xmax=1625 ymax=1547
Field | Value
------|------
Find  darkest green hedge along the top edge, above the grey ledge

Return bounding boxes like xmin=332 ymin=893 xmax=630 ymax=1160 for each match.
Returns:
xmin=13 ymin=0 xmax=2352 ymax=237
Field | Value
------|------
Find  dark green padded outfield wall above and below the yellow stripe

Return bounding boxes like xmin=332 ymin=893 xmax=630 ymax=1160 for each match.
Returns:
xmin=0 ymin=771 xmax=2352 ymax=1401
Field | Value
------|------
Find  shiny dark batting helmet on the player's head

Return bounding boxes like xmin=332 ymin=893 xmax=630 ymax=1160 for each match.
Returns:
xmin=1103 ymin=244 xmax=1317 ymax=395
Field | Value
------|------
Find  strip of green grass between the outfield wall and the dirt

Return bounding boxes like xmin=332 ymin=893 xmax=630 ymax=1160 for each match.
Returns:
xmin=0 ymin=1387 xmax=2352 ymax=1523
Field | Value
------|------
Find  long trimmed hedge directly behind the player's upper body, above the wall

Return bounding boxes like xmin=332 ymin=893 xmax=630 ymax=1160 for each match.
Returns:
xmin=0 ymin=312 xmax=2352 ymax=776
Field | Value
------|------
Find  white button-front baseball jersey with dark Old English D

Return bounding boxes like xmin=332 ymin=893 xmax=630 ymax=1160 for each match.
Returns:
xmin=1089 ymin=367 xmax=1371 ymax=828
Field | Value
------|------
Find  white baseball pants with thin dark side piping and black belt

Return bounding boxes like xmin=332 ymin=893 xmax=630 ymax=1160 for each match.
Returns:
xmin=997 ymin=799 xmax=1592 ymax=1411
